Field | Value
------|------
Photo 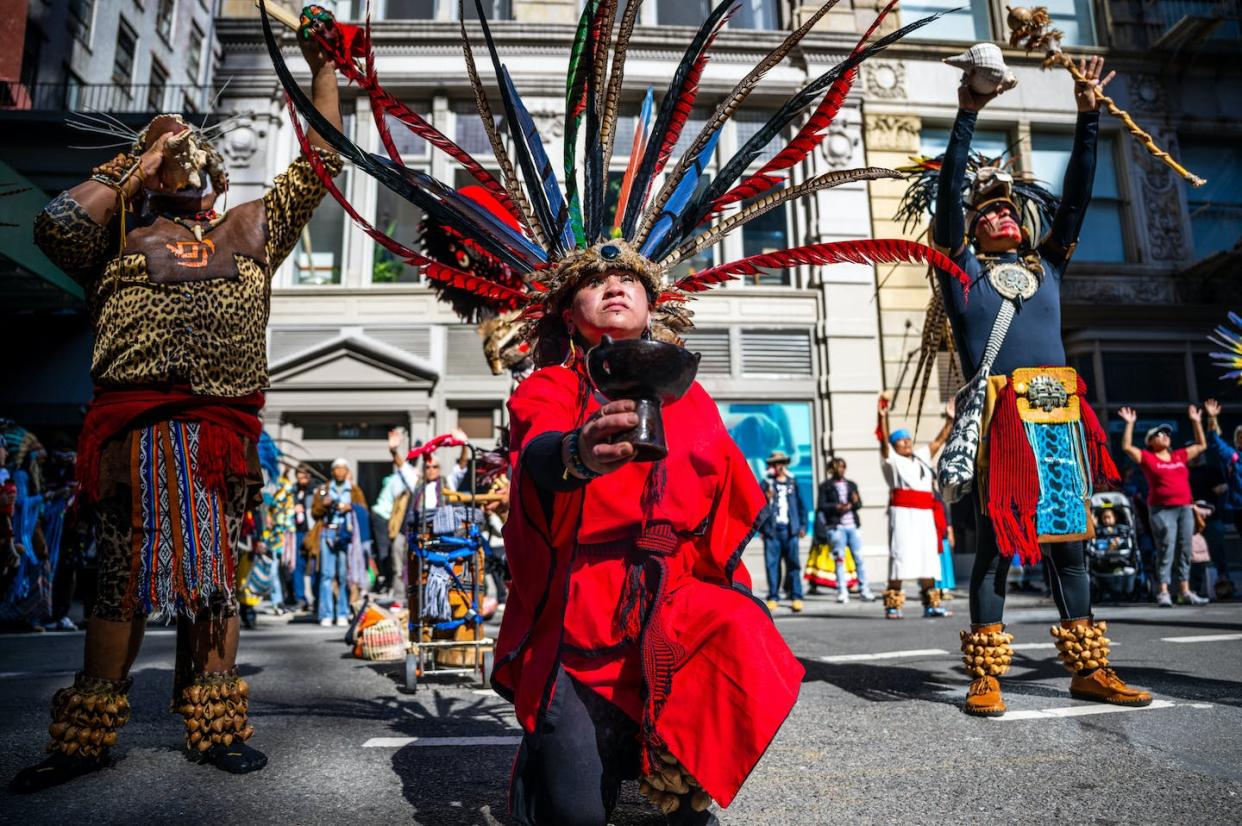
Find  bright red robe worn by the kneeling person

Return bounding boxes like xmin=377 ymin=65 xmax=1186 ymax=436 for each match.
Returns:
xmin=493 ymin=366 xmax=804 ymax=806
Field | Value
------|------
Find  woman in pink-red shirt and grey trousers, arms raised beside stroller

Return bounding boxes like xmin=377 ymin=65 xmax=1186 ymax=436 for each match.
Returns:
xmin=1118 ymin=405 xmax=1207 ymax=607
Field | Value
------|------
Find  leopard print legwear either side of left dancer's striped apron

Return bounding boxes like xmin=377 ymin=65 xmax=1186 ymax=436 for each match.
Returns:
xmin=91 ymin=467 xmax=247 ymax=622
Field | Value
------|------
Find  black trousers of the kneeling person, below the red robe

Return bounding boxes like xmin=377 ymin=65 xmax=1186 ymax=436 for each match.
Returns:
xmin=509 ymin=669 xmax=718 ymax=826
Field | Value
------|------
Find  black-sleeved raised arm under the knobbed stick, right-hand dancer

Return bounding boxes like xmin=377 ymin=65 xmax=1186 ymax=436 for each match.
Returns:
xmin=1043 ymin=57 xmax=1117 ymax=263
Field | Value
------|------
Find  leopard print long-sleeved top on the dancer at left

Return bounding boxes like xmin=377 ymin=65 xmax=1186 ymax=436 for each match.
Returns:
xmin=35 ymin=155 xmax=342 ymax=396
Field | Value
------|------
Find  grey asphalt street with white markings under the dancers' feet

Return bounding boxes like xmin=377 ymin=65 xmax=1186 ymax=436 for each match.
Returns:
xmin=0 ymin=588 xmax=1242 ymax=826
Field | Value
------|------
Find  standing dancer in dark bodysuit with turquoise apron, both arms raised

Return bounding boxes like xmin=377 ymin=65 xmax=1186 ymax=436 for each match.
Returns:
xmin=905 ymin=57 xmax=1151 ymax=715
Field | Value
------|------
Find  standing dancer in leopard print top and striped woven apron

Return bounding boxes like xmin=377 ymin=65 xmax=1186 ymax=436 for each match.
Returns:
xmin=12 ymin=8 xmax=340 ymax=791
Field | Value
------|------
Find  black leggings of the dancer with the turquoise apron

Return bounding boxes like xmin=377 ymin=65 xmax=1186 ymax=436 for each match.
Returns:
xmin=970 ymin=501 xmax=1090 ymax=625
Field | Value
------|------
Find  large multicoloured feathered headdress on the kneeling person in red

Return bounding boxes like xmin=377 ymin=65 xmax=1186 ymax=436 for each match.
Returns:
xmin=260 ymin=0 xmax=965 ymax=357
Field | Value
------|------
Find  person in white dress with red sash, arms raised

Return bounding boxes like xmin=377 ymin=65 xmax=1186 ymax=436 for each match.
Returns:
xmin=877 ymin=395 xmax=953 ymax=620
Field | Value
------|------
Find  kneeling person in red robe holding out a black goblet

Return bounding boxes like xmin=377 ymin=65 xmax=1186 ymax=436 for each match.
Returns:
xmin=493 ymin=241 xmax=804 ymax=825
